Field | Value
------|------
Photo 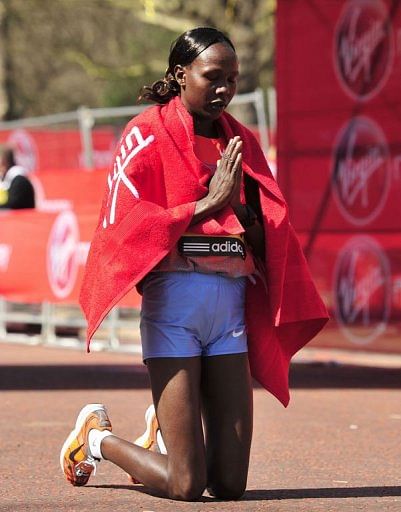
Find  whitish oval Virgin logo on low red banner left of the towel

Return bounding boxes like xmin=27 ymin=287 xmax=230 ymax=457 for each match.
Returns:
xmin=47 ymin=211 xmax=79 ymax=299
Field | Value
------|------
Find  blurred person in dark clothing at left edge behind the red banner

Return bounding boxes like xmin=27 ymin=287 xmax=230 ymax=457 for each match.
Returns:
xmin=0 ymin=146 xmax=35 ymax=210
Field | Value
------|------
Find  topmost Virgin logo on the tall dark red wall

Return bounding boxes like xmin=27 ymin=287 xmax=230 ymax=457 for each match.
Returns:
xmin=334 ymin=0 xmax=394 ymax=99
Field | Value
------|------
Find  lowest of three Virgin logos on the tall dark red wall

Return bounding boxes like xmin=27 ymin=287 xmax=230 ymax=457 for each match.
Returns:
xmin=334 ymin=236 xmax=391 ymax=344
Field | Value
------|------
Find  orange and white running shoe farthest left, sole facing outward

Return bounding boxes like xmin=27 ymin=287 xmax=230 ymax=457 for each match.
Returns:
xmin=60 ymin=404 xmax=111 ymax=486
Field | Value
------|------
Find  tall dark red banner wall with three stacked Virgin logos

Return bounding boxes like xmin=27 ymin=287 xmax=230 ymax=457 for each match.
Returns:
xmin=277 ymin=0 xmax=401 ymax=351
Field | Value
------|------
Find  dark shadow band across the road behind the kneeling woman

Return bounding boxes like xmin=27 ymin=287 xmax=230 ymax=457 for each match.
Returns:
xmin=0 ymin=363 xmax=401 ymax=390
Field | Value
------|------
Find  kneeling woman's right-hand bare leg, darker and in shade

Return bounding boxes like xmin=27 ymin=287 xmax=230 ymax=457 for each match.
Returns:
xmin=202 ymin=354 xmax=253 ymax=499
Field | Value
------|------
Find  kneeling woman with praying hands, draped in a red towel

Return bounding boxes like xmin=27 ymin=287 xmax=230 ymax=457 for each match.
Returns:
xmin=60 ymin=27 xmax=327 ymax=500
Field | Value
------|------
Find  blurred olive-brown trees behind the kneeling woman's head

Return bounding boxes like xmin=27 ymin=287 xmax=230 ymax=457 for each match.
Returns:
xmin=0 ymin=0 xmax=275 ymax=119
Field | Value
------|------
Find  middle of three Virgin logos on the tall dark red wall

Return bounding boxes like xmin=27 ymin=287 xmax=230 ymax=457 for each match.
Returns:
xmin=332 ymin=116 xmax=391 ymax=226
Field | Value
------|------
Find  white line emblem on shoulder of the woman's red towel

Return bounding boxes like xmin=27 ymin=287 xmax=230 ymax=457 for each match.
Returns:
xmin=103 ymin=126 xmax=155 ymax=228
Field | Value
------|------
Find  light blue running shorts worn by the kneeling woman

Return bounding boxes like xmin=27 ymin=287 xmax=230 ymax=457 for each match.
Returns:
xmin=140 ymin=272 xmax=248 ymax=361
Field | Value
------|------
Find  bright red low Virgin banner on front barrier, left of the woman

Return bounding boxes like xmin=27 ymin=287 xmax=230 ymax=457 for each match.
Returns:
xmin=0 ymin=210 xmax=140 ymax=307
